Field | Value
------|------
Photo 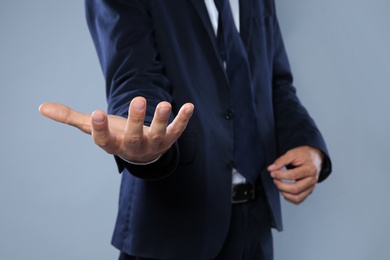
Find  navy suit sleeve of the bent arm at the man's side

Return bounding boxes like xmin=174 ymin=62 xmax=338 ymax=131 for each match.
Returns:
xmin=273 ymin=15 xmax=332 ymax=182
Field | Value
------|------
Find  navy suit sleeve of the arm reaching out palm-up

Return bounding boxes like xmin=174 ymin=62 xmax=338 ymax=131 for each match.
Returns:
xmin=85 ymin=0 xmax=178 ymax=179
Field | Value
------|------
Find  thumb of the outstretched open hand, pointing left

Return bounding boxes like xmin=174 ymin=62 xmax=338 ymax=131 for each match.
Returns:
xmin=39 ymin=102 xmax=91 ymax=134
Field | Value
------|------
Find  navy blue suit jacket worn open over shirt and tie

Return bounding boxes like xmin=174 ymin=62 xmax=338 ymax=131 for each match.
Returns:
xmin=86 ymin=0 xmax=330 ymax=259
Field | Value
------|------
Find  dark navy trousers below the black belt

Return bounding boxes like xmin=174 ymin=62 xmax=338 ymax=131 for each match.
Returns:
xmin=119 ymin=197 xmax=273 ymax=260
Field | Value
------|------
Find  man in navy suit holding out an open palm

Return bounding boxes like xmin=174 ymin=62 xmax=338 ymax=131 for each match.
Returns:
xmin=40 ymin=0 xmax=331 ymax=260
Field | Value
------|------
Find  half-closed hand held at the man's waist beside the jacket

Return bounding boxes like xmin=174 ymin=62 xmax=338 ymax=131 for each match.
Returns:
xmin=268 ymin=146 xmax=323 ymax=204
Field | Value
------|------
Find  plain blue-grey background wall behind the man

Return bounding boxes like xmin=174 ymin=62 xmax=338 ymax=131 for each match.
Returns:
xmin=0 ymin=0 xmax=390 ymax=260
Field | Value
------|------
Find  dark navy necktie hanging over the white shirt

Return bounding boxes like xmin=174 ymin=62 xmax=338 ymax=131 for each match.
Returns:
xmin=214 ymin=0 xmax=264 ymax=184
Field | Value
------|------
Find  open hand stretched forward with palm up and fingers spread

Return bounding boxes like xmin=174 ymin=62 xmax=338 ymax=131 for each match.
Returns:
xmin=39 ymin=97 xmax=194 ymax=163
